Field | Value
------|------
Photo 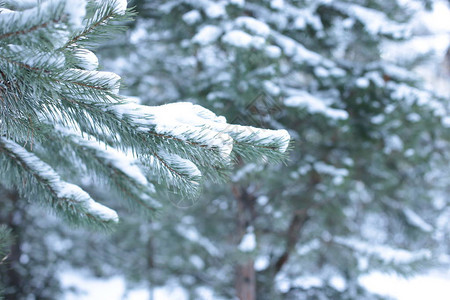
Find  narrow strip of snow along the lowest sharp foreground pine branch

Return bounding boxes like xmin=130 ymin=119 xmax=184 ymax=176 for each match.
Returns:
xmin=0 ymin=138 xmax=119 ymax=226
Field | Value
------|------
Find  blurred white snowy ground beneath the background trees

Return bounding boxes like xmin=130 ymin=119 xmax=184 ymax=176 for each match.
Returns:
xmin=61 ymin=270 xmax=450 ymax=300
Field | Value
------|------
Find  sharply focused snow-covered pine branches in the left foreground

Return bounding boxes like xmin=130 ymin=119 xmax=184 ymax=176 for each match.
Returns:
xmin=0 ymin=0 xmax=289 ymax=299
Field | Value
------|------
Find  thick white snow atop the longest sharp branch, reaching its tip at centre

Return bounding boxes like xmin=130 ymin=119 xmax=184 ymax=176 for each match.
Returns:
xmin=111 ymin=102 xmax=290 ymax=157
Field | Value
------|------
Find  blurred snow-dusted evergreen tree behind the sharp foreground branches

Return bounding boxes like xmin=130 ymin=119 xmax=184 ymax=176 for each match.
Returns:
xmin=96 ymin=0 xmax=448 ymax=299
